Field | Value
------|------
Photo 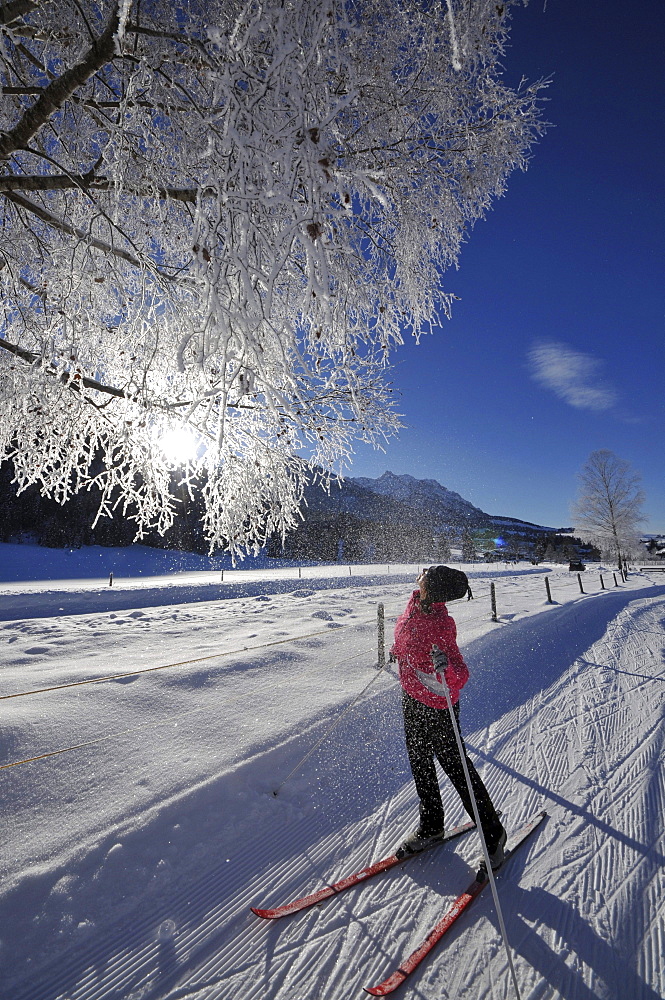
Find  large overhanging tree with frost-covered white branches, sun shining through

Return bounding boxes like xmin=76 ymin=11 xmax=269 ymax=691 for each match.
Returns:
xmin=0 ymin=0 xmax=543 ymax=553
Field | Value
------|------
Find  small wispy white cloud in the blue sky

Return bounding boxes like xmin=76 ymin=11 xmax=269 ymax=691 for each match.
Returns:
xmin=529 ymin=341 xmax=617 ymax=410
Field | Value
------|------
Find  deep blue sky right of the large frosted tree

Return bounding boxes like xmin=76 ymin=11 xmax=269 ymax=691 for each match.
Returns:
xmin=348 ymin=0 xmax=665 ymax=532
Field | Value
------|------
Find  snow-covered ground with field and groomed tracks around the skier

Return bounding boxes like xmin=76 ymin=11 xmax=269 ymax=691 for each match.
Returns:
xmin=0 ymin=545 xmax=665 ymax=1000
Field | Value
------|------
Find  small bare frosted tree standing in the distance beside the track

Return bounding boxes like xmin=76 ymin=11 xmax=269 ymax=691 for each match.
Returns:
xmin=572 ymin=448 xmax=646 ymax=568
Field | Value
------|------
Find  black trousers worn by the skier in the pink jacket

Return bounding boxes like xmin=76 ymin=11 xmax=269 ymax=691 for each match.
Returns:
xmin=402 ymin=691 xmax=503 ymax=853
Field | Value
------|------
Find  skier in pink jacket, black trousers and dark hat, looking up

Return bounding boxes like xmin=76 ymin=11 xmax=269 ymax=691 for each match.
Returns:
xmin=391 ymin=566 xmax=506 ymax=868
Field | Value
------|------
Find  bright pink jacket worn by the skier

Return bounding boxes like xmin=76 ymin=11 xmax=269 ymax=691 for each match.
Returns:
xmin=391 ymin=590 xmax=469 ymax=708
